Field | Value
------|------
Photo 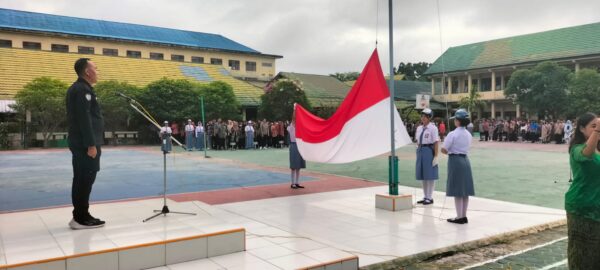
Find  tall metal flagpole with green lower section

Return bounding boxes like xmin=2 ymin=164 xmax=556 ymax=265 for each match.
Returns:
xmin=388 ymin=0 xmax=398 ymax=195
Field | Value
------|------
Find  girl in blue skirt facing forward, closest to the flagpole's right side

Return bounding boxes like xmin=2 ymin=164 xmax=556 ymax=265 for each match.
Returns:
xmin=415 ymin=108 xmax=440 ymax=205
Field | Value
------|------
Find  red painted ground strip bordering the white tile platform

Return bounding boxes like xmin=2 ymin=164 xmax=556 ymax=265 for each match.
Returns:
xmin=168 ymin=173 xmax=384 ymax=204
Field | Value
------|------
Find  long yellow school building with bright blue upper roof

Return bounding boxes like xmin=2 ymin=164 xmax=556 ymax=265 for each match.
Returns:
xmin=0 ymin=9 xmax=282 ymax=118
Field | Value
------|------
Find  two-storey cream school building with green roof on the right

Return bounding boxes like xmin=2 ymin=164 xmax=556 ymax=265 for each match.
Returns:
xmin=425 ymin=23 xmax=600 ymax=119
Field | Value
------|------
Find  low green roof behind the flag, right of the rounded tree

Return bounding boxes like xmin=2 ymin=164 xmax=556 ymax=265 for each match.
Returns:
xmin=275 ymin=72 xmax=351 ymax=107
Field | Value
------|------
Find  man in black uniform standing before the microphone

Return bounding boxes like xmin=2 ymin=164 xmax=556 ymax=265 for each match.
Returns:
xmin=67 ymin=58 xmax=105 ymax=230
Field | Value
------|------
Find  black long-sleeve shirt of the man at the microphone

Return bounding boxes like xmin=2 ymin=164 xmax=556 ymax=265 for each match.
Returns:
xmin=67 ymin=78 xmax=104 ymax=148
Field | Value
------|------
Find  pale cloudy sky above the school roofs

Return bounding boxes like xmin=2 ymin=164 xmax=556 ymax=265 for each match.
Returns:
xmin=0 ymin=0 xmax=600 ymax=74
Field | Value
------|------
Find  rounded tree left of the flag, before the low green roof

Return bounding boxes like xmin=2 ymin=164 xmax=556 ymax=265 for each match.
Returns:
xmin=258 ymin=79 xmax=312 ymax=121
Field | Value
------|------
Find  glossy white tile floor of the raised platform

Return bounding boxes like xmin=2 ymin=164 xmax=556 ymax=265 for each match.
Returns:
xmin=0 ymin=186 xmax=564 ymax=270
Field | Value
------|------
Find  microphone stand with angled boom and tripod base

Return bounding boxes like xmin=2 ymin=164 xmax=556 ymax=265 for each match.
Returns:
xmin=117 ymin=92 xmax=196 ymax=222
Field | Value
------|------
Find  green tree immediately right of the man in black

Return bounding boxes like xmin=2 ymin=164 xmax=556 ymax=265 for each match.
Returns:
xmin=94 ymin=80 xmax=141 ymax=132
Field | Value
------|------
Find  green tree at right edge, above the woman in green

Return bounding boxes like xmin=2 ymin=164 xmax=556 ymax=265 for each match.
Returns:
xmin=569 ymin=69 xmax=600 ymax=117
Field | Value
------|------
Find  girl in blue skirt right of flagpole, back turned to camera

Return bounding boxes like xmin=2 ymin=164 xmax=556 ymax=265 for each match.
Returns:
xmin=442 ymin=109 xmax=475 ymax=224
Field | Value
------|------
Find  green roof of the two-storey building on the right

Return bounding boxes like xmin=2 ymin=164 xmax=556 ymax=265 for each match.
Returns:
xmin=425 ymin=23 xmax=600 ymax=75
